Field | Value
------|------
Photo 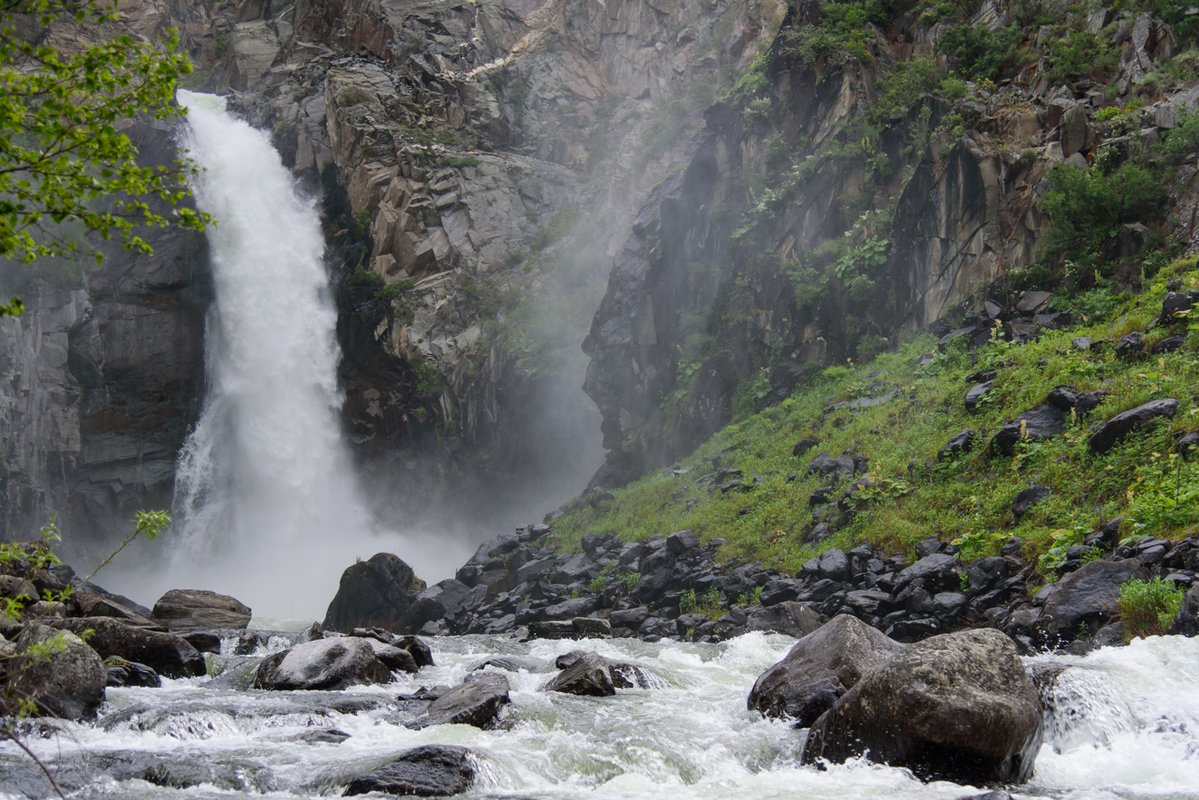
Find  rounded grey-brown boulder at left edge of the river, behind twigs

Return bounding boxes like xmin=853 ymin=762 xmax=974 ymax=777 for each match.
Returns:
xmin=0 ymin=624 xmax=108 ymax=720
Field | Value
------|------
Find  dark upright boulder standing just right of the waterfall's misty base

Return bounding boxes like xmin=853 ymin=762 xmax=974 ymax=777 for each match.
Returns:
xmin=324 ymin=553 xmax=424 ymax=632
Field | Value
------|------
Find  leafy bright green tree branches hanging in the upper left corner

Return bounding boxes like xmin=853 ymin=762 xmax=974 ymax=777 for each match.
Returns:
xmin=0 ymin=0 xmax=207 ymax=317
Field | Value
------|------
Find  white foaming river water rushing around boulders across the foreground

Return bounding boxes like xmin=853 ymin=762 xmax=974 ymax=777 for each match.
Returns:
xmin=0 ymin=633 xmax=1199 ymax=800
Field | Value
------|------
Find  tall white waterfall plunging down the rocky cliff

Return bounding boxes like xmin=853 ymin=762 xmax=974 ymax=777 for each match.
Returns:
xmin=151 ymin=91 xmax=404 ymax=619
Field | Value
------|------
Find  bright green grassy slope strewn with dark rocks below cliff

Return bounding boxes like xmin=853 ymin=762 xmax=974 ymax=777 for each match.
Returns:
xmin=554 ymin=253 xmax=1199 ymax=579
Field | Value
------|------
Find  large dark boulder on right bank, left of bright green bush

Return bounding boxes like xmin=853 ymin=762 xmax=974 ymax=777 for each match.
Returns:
xmin=1037 ymin=559 xmax=1146 ymax=645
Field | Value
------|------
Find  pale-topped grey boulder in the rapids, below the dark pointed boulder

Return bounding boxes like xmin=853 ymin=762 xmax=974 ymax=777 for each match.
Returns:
xmin=254 ymin=637 xmax=392 ymax=690
